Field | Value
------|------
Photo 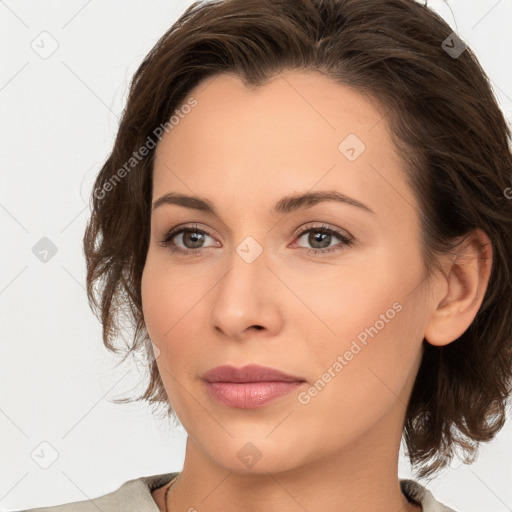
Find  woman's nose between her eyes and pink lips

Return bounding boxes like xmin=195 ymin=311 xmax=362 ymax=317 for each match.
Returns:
xmin=211 ymin=243 xmax=286 ymax=340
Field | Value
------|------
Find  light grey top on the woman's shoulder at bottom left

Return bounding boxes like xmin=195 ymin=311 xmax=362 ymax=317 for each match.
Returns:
xmin=19 ymin=473 xmax=177 ymax=512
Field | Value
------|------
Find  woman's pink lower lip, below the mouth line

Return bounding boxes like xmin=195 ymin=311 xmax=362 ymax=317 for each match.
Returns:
xmin=206 ymin=381 xmax=304 ymax=409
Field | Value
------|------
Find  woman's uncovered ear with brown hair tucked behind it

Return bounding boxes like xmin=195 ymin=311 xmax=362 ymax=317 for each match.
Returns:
xmin=424 ymin=228 xmax=492 ymax=346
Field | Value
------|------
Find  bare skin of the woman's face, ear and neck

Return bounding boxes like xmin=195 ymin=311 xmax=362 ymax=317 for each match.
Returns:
xmin=142 ymin=71 xmax=491 ymax=512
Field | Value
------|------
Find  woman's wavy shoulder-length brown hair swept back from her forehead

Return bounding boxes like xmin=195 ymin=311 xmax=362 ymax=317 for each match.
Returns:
xmin=84 ymin=0 xmax=512 ymax=477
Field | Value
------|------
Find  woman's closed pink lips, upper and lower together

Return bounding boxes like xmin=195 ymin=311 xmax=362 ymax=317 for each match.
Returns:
xmin=202 ymin=365 xmax=306 ymax=409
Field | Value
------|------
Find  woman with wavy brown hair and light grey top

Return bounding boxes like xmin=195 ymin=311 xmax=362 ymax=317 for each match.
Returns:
xmin=19 ymin=0 xmax=512 ymax=512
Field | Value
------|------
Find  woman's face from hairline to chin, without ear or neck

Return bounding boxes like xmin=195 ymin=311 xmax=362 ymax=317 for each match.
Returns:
xmin=142 ymin=71 xmax=430 ymax=472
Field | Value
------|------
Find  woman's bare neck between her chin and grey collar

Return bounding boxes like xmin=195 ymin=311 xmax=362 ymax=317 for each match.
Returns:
xmin=157 ymin=418 xmax=422 ymax=512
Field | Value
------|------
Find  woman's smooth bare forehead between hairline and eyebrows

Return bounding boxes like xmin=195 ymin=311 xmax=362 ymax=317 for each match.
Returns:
xmin=153 ymin=71 xmax=413 ymax=222
